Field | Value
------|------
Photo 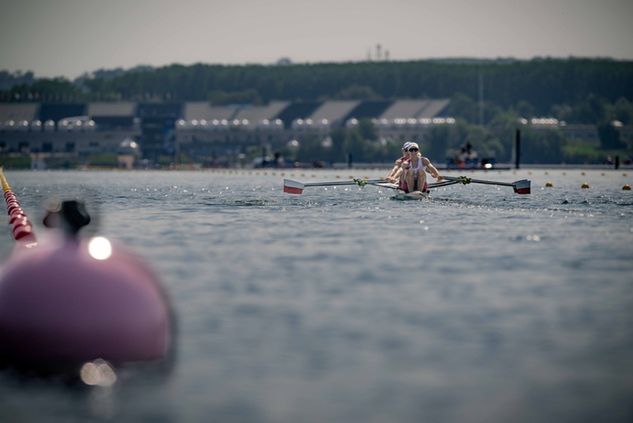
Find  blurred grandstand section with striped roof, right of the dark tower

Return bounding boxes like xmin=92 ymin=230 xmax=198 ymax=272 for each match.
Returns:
xmin=175 ymin=100 xmax=455 ymax=161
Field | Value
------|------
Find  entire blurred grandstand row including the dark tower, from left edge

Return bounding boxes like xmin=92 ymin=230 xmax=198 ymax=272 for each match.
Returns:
xmin=0 ymin=99 xmax=455 ymax=163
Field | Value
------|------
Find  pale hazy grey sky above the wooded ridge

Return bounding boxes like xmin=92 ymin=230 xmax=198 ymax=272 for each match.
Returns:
xmin=0 ymin=0 xmax=633 ymax=78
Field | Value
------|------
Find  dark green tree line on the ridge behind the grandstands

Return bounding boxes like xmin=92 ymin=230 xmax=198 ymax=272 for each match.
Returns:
xmin=0 ymin=58 xmax=633 ymax=120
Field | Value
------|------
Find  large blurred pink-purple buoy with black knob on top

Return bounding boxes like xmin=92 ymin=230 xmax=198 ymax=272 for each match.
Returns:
xmin=0 ymin=201 xmax=172 ymax=369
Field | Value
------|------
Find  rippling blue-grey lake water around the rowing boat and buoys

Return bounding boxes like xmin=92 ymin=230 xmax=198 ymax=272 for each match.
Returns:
xmin=0 ymin=170 xmax=633 ymax=422
